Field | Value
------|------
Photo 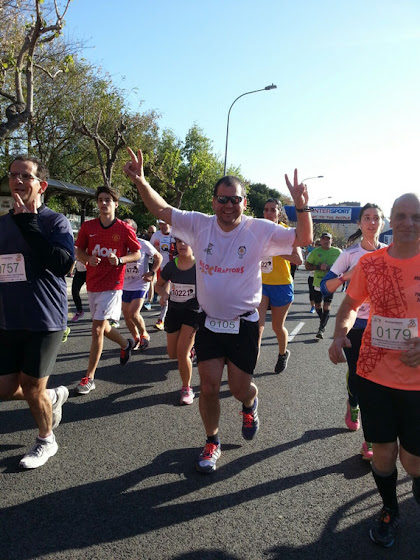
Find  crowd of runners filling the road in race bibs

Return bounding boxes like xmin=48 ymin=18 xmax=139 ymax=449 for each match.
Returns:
xmin=0 ymin=149 xmax=420 ymax=547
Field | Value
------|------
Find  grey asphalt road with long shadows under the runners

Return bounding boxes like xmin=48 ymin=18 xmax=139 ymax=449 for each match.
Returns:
xmin=0 ymin=270 xmax=420 ymax=560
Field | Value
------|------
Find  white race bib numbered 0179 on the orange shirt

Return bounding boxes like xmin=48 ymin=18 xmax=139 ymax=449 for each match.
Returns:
xmin=372 ymin=315 xmax=418 ymax=350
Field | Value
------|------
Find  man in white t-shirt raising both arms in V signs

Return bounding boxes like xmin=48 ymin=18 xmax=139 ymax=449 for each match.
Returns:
xmin=124 ymin=148 xmax=312 ymax=473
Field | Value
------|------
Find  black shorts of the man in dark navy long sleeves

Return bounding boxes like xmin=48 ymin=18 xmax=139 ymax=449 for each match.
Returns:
xmin=0 ymin=329 xmax=64 ymax=379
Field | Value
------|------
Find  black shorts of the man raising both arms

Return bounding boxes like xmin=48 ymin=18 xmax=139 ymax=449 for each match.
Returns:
xmin=195 ymin=313 xmax=259 ymax=375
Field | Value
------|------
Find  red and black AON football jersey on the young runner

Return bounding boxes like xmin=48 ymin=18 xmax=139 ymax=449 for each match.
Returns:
xmin=76 ymin=218 xmax=140 ymax=292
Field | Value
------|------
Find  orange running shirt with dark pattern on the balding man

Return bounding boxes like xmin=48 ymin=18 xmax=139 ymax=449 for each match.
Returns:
xmin=347 ymin=247 xmax=420 ymax=391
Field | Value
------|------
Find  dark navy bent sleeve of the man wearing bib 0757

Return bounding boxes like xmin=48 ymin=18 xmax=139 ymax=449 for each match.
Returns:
xmin=13 ymin=213 xmax=74 ymax=277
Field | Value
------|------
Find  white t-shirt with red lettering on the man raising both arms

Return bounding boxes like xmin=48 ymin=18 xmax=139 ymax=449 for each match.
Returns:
xmin=172 ymin=209 xmax=296 ymax=320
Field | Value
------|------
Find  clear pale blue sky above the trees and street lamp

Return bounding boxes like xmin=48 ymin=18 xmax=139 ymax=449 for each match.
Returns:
xmin=66 ymin=0 xmax=420 ymax=215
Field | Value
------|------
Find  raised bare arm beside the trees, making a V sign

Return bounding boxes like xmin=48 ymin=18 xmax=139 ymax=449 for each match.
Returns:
xmin=124 ymin=148 xmax=172 ymax=228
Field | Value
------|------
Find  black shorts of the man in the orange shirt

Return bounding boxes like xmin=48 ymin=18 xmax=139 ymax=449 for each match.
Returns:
xmin=357 ymin=375 xmax=420 ymax=457
